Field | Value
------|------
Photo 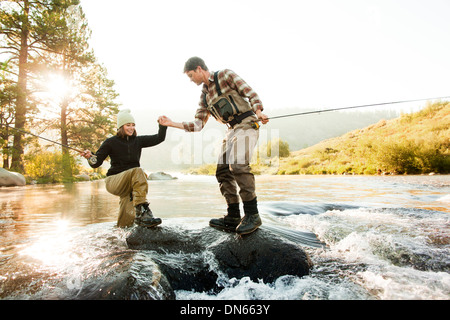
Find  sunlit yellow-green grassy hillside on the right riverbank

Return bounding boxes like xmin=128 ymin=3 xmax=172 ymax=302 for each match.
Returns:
xmin=280 ymin=102 xmax=450 ymax=174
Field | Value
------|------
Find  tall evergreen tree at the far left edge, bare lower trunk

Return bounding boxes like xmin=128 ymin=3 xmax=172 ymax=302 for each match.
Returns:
xmin=0 ymin=0 xmax=78 ymax=172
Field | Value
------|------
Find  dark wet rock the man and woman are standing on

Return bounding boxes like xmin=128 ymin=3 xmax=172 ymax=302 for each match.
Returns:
xmin=127 ymin=225 xmax=311 ymax=291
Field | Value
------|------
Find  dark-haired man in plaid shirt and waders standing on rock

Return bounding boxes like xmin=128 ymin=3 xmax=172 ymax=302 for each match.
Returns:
xmin=161 ymin=57 xmax=269 ymax=234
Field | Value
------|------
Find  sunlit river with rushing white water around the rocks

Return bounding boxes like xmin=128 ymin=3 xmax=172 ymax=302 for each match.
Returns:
xmin=0 ymin=174 xmax=450 ymax=300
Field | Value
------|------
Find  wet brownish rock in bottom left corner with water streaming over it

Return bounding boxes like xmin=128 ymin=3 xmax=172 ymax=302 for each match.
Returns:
xmin=0 ymin=250 xmax=175 ymax=300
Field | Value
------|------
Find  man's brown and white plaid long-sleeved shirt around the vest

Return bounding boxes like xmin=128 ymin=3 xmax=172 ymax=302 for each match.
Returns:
xmin=183 ymin=69 xmax=264 ymax=132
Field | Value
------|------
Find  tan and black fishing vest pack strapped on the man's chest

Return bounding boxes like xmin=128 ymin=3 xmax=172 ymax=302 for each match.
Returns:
xmin=203 ymin=71 xmax=254 ymax=126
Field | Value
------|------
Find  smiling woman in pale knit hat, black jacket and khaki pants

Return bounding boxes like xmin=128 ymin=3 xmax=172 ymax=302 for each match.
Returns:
xmin=81 ymin=109 xmax=167 ymax=227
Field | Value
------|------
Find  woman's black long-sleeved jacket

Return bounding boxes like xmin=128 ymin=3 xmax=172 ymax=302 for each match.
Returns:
xmin=89 ymin=125 xmax=167 ymax=176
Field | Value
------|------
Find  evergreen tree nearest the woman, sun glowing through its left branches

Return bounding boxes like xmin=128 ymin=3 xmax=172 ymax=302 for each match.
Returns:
xmin=33 ymin=5 xmax=118 ymax=178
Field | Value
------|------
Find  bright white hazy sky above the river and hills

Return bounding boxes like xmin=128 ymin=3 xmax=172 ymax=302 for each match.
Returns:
xmin=81 ymin=0 xmax=450 ymax=133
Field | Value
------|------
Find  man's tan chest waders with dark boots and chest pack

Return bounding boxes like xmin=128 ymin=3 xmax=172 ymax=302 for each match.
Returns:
xmin=203 ymin=72 xmax=262 ymax=234
